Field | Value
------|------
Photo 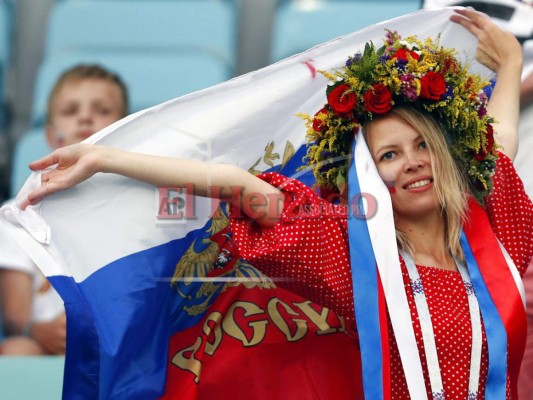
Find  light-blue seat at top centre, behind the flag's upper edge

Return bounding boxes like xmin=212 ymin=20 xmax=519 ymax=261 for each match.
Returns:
xmin=271 ymin=0 xmax=420 ymax=61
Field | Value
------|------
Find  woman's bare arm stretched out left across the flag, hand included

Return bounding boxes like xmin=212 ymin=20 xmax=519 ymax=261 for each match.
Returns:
xmin=23 ymin=144 xmax=283 ymax=227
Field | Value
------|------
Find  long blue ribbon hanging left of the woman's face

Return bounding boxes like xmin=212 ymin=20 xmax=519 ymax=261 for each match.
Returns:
xmin=348 ymin=140 xmax=387 ymax=400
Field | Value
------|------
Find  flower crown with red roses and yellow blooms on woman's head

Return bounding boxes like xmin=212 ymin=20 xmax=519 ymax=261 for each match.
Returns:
xmin=302 ymin=31 xmax=497 ymax=202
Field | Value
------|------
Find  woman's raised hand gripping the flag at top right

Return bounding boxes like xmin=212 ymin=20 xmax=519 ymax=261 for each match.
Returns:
xmin=451 ymin=8 xmax=523 ymax=73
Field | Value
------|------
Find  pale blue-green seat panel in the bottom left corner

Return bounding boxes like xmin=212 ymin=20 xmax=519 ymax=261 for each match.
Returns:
xmin=0 ymin=356 xmax=65 ymax=400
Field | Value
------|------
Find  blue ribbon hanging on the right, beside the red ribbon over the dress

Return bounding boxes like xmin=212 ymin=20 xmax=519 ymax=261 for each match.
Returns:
xmin=461 ymin=232 xmax=507 ymax=400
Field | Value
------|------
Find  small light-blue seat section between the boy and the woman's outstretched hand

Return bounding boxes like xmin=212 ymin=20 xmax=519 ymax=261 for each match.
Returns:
xmin=10 ymin=128 xmax=51 ymax=196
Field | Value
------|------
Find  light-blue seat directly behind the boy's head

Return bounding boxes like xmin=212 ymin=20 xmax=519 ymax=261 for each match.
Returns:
xmin=32 ymin=50 xmax=232 ymax=127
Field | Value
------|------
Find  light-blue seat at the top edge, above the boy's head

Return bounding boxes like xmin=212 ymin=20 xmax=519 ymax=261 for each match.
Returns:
xmin=45 ymin=0 xmax=238 ymax=68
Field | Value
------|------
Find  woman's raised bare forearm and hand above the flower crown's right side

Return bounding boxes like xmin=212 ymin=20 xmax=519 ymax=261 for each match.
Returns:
xmin=452 ymin=9 xmax=523 ymax=160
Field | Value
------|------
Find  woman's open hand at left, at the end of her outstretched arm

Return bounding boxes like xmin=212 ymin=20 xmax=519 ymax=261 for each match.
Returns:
xmin=22 ymin=143 xmax=102 ymax=209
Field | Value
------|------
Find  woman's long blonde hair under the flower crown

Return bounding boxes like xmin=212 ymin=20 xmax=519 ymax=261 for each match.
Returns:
xmin=363 ymin=107 xmax=468 ymax=260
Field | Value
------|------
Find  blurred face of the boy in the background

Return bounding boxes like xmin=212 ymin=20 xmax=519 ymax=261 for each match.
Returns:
xmin=46 ymin=78 xmax=125 ymax=149
